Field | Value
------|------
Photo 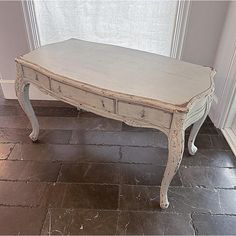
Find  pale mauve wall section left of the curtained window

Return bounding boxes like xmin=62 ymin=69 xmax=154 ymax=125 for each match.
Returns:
xmin=0 ymin=1 xmax=29 ymax=80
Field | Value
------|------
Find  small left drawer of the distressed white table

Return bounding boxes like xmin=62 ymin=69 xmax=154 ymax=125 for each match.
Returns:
xmin=23 ymin=67 xmax=50 ymax=89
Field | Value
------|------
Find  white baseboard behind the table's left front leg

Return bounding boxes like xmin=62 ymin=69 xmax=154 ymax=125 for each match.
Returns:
xmin=0 ymin=80 xmax=56 ymax=100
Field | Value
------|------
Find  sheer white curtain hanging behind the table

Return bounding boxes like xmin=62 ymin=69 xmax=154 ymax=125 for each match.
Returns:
xmin=34 ymin=0 xmax=178 ymax=56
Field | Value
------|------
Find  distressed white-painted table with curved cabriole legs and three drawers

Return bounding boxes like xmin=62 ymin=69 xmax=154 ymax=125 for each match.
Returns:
xmin=15 ymin=39 xmax=215 ymax=208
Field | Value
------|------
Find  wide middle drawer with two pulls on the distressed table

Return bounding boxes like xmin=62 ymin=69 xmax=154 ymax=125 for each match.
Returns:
xmin=51 ymin=80 xmax=115 ymax=113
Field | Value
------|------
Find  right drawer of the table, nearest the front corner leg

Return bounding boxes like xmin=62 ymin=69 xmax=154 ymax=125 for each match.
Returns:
xmin=117 ymin=101 xmax=172 ymax=128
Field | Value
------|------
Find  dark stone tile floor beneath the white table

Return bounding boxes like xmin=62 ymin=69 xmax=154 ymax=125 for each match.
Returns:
xmin=0 ymin=99 xmax=236 ymax=235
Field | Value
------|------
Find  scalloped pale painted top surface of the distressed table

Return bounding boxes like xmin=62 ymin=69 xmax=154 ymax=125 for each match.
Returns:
xmin=17 ymin=39 xmax=214 ymax=111
